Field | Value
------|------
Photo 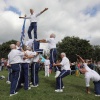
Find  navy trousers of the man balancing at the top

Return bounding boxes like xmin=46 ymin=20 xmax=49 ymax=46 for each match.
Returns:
xmin=28 ymin=22 xmax=37 ymax=39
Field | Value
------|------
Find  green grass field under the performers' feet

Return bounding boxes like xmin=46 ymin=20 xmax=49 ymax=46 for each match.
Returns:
xmin=0 ymin=70 xmax=100 ymax=100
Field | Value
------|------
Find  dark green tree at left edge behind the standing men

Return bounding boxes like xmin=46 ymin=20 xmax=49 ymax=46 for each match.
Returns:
xmin=0 ymin=40 xmax=17 ymax=58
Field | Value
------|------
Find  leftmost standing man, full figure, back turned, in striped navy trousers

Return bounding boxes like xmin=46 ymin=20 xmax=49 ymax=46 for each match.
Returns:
xmin=8 ymin=44 xmax=25 ymax=96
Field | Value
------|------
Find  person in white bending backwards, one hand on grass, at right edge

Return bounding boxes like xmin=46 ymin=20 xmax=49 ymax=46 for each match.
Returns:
xmin=77 ymin=55 xmax=100 ymax=96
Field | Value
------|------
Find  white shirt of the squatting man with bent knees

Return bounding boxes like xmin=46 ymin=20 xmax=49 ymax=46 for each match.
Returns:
xmin=60 ymin=57 xmax=71 ymax=70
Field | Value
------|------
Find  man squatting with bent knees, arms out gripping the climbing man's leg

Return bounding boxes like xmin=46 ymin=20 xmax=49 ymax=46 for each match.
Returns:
xmin=53 ymin=53 xmax=71 ymax=92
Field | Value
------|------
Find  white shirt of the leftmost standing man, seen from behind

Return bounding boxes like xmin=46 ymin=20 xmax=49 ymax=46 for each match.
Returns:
xmin=8 ymin=49 xmax=24 ymax=64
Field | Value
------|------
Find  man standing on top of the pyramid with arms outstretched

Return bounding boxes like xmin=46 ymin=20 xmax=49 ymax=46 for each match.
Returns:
xmin=19 ymin=8 xmax=48 ymax=39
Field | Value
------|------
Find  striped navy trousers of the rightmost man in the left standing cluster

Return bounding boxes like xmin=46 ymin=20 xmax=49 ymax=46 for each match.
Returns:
xmin=32 ymin=62 xmax=40 ymax=86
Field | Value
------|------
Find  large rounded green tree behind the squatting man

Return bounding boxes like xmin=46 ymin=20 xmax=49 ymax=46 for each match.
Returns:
xmin=57 ymin=37 xmax=93 ymax=62
